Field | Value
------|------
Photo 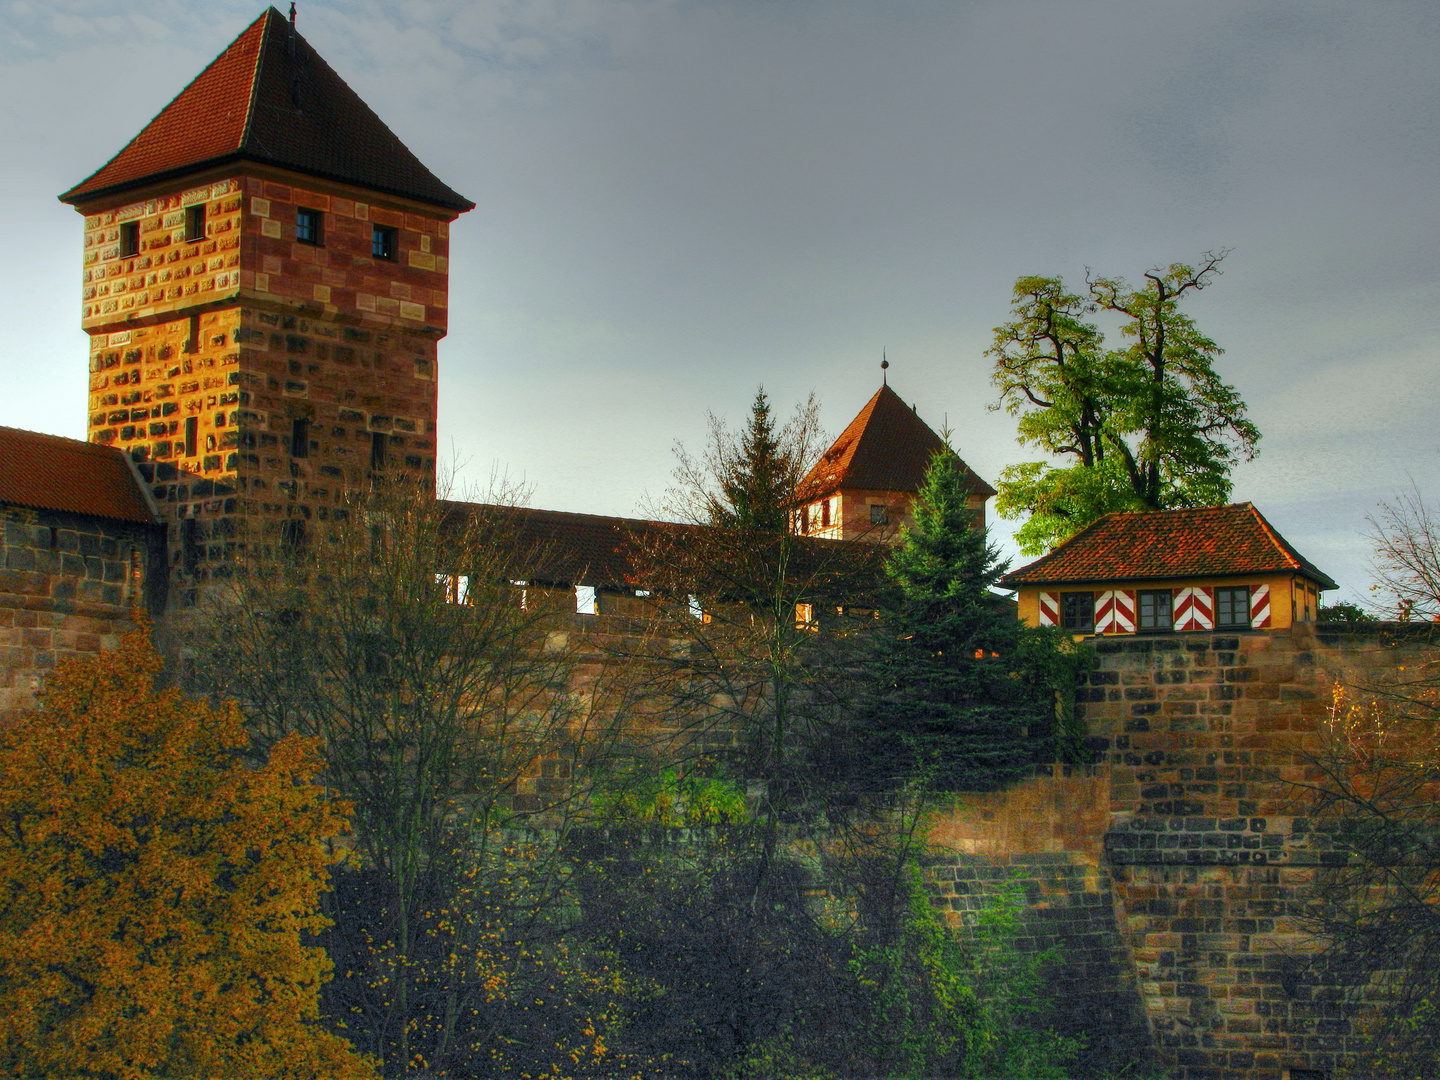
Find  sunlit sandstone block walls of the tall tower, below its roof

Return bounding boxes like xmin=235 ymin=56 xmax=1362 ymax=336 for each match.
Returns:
xmin=82 ymin=167 xmax=454 ymax=608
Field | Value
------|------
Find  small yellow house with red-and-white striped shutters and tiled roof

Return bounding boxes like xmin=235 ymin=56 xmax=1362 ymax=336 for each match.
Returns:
xmin=999 ymin=503 xmax=1339 ymax=635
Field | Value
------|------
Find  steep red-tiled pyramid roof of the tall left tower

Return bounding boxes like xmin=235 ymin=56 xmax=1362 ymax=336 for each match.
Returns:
xmin=60 ymin=7 xmax=475 ymax=212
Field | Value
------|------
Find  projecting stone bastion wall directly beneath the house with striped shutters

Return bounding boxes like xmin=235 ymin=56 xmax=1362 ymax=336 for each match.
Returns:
xmin=1080 ymin=624 xmax=1426 ymax=1080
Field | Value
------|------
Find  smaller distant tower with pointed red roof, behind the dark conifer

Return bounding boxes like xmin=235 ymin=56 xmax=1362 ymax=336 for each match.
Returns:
xmin=798 ymin=384 xmax=995 ymax=543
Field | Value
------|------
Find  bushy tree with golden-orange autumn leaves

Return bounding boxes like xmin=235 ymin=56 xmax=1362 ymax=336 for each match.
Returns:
xmin=0 ymin=632 xmax=374 ymax=1080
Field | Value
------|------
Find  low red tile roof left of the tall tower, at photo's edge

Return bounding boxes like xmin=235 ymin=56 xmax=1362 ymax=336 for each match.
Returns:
xmin=0 ymin=428 xmax=156 ymax=524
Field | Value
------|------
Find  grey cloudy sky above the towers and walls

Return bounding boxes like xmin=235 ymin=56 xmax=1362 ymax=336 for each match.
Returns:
xmin=0 ymin=0 xmax=1440 ymax=599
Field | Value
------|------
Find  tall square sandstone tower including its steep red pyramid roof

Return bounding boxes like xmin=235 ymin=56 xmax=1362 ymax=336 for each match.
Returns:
xmin=60 ymin=7 xmax=474 ymax=606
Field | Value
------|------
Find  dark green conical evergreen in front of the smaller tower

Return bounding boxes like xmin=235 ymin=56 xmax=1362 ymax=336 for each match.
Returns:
xmin=841 ymin=452 xmax=1076 ymax=791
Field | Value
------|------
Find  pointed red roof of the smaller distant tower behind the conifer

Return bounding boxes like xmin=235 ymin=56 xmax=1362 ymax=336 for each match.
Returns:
xmin=805 ymin=386 xmax=995 ymax=498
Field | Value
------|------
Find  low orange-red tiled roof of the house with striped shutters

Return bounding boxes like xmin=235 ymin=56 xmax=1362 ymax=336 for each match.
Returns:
xmin=999 ymin=503 xmax=1339 ymax=589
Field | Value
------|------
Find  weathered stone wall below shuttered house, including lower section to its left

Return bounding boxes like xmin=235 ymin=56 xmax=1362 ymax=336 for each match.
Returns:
xmin=904 ymin=624 xmax=1440 ymax=1080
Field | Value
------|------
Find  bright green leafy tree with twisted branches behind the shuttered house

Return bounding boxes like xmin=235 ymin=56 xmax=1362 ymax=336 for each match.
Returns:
xmin=988 ymin=251 xmax=1260 ymax=554
